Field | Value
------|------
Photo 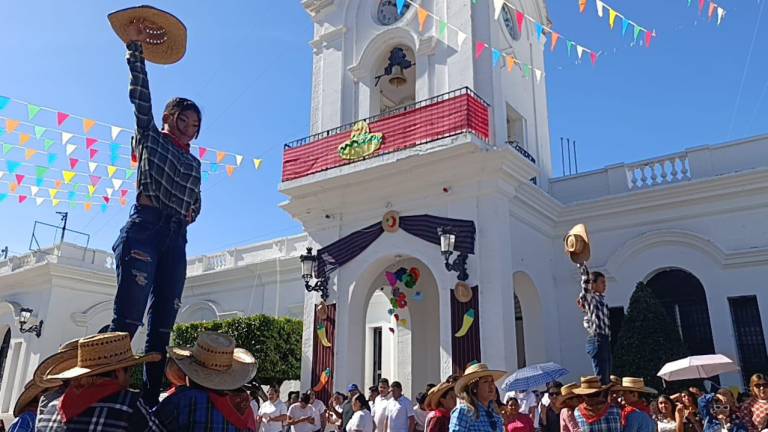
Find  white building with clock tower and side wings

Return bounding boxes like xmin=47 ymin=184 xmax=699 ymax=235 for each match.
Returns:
xmin=0 ymin=0 xmax=768 ymax=420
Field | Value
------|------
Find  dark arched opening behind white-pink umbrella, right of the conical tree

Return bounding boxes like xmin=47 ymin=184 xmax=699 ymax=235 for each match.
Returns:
xmin=646 ymin=269 xmax=715 ymax=355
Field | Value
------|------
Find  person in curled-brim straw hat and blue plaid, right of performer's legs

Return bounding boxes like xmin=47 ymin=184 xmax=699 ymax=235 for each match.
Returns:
xmin=155 ymin=331 xmax=256 ymax=432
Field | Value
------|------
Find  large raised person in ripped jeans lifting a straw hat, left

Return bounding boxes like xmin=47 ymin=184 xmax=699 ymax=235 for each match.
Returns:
xmin=109 ymin=6 xmax=202 ymax=407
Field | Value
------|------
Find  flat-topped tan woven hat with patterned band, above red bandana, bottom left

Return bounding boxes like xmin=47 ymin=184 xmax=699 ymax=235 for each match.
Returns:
xmin=43 ymin=332 xmax=161 ymax=381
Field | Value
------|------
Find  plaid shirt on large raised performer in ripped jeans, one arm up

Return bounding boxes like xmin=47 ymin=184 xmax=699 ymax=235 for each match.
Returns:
xmin=127 ymin=42 xmax=201 ymax=222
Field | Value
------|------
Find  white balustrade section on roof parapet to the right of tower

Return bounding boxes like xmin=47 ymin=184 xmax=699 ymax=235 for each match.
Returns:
xmin=625 ymin=153 xmax=691 ymax=190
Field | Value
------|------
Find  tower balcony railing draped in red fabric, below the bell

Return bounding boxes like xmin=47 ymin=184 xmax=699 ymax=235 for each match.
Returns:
xmin=283 ymin=87 xmax=490 ymax=181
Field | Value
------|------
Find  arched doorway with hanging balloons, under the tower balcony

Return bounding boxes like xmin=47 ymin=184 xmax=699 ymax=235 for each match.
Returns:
xmin=364 ymin=258 xmax=441 ymax=397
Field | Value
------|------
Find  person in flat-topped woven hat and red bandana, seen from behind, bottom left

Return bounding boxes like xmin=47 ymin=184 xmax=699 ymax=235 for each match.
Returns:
xmin=36 ymin=333 xmax=161 ymax=432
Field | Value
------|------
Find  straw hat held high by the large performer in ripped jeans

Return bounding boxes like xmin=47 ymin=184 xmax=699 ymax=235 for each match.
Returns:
xmin=107 ymin=6 xmax=187 ymax=64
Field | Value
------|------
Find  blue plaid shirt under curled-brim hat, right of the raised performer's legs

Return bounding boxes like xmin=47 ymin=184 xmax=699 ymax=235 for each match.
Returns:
xmin=155 ymin=387 xmax=250 ymax=432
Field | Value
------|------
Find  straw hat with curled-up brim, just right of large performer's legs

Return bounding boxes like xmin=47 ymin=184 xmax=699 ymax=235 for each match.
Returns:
xmin=168 ymin=331 xmax=256 ymax=390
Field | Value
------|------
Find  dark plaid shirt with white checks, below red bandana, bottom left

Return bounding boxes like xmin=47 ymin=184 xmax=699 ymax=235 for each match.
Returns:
xmin=36 ymin=390 xmax=162 ymax=432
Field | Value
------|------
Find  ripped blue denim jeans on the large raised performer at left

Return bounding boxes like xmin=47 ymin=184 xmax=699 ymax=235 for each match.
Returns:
xmin=110 ymin=204 xmax=187 ymax=407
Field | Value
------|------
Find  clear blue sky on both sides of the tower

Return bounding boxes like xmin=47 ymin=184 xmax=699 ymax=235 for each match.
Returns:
xmin=0 ymin=0 xmax=768 ymax=256
